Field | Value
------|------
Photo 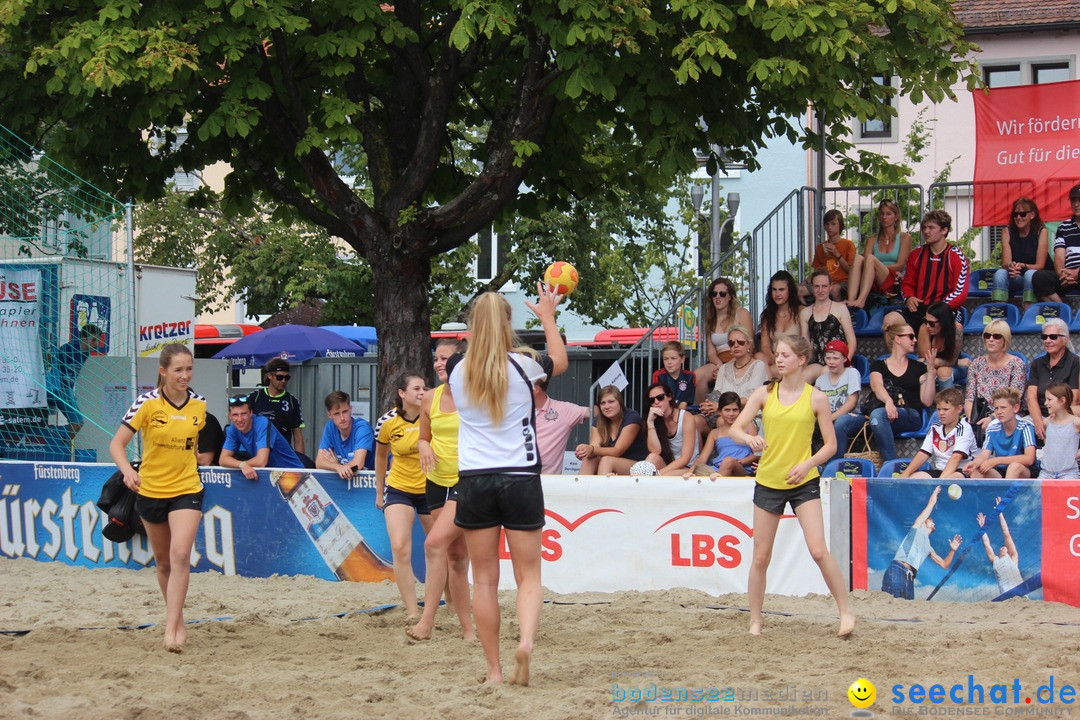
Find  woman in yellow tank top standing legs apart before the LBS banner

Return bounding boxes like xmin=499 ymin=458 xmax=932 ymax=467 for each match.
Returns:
xmin=730 ymin=335 xmax=855 ymax=637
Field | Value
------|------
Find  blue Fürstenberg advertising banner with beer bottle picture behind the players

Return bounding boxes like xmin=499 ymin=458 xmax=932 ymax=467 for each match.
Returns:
xmin=0 ymin=461 xmax=424 ymax=582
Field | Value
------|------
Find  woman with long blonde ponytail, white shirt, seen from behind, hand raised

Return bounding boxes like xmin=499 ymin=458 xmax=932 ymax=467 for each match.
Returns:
xmin=447 ymin=283 xmax=568 ymax=685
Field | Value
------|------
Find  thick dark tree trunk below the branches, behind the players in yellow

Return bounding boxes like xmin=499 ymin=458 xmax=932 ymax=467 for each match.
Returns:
xmin=372 ymin=250 xmax=432 ymax=410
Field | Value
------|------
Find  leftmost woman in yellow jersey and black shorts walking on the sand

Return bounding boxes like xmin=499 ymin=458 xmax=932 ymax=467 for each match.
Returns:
xmin=109 ymin=343 xmax=206 ymax=652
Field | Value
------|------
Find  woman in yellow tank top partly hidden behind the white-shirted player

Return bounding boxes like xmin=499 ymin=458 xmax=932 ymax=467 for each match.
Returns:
xmin=405 ymin=338 xmax=476 ymax=640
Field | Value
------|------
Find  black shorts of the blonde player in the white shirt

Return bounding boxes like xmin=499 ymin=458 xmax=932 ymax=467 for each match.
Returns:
xmin=454 ymin=474 xmax=544 ymax=530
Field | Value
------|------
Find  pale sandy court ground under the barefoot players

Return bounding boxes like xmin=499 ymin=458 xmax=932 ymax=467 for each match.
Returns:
xmin=6 ymin=559 xmax=1080 ymax=720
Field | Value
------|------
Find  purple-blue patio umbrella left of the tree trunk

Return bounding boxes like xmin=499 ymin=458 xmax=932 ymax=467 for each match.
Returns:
xmin=214 ymin=325 xmax=367 ymax=368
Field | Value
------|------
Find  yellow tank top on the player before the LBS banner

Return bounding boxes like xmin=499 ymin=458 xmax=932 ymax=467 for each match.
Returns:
xmin=756 ymin=383 xmax=818 ymax=490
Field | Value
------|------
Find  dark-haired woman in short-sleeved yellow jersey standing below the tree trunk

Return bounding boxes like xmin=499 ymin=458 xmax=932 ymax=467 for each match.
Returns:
xmin=375 ymin=372 xmax=432 ymax=620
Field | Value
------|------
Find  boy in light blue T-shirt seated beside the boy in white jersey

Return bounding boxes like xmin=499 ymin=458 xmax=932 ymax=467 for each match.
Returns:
xmin=963 ymin=388 xmax=1038 ymax=478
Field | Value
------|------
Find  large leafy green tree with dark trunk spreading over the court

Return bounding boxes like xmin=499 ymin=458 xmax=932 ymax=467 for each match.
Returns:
xmin=0 ymin=0 xmax=970 ymax=398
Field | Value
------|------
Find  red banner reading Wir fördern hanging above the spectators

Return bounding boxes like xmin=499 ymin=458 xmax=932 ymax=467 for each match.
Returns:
xmin=972 ymin=80 xmax=1080 ymax=226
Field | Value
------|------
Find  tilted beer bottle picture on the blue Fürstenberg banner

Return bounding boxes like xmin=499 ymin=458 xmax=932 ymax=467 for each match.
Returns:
xmin=270 ymin=471 xmax=394 ymax=582
